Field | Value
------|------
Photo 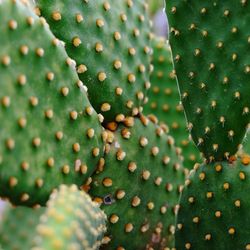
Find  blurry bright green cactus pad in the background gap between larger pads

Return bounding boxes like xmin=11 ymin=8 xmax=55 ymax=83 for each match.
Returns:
xmin=143 ymin=37 xmax=201 ymax=169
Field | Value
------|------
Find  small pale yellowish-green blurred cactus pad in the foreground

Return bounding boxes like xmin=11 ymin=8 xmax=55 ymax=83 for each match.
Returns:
xmin=32 ymin=185 xmax=106 ymax=250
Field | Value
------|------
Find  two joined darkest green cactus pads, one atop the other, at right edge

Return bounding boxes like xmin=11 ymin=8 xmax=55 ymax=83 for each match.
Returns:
xmin=166 ymin=0 xmax=250 ymax=250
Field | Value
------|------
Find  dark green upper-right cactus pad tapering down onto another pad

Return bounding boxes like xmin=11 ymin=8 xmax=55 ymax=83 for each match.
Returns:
xmin=166 ymin=0 xmax=250 ymax=161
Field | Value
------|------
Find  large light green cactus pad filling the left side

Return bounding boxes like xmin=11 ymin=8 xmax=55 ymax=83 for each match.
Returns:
xmin=0 ymin=0 xmax=103 ymax=206
